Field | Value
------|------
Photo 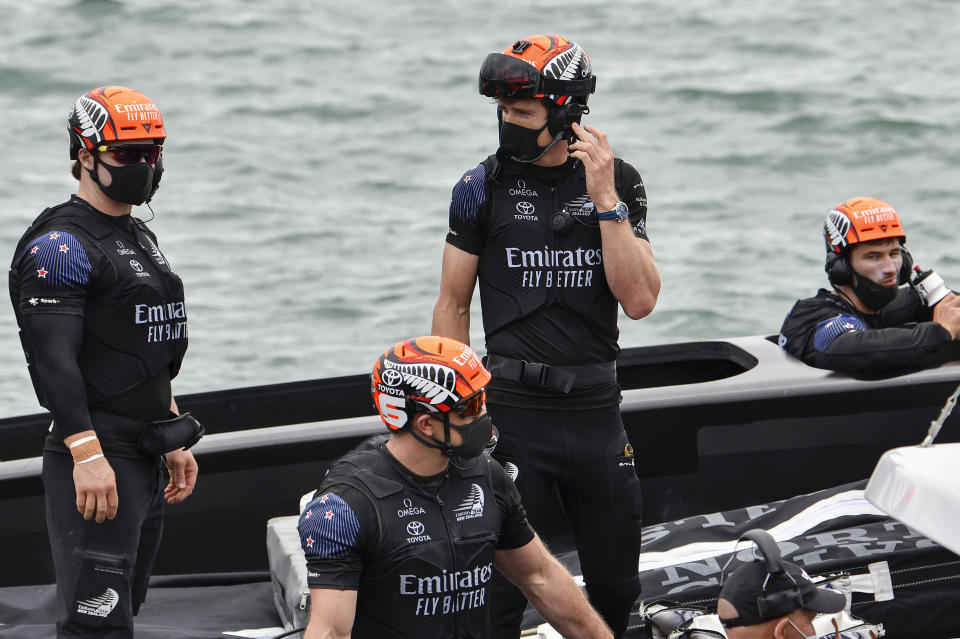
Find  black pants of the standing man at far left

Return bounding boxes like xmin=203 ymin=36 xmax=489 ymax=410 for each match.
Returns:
xmin=42 ymin=451 xmax=165 ymax=639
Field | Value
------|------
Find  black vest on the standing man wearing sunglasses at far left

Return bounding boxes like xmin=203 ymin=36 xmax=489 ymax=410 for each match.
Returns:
xmin=11 ymin=199 xmax=187 ymax=406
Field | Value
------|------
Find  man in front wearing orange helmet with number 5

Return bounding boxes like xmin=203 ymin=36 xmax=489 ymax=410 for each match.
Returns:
xmin=299 ymin=337 xmax=612 ymax=639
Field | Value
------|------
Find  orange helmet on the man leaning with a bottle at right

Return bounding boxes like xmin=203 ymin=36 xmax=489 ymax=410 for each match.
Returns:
xmin=823 ymin=197 xmax=907 ymax=254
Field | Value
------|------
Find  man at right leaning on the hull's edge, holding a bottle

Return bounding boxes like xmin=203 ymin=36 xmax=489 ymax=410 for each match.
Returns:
xmin=780 ymin=197 xmax=960 ymax=376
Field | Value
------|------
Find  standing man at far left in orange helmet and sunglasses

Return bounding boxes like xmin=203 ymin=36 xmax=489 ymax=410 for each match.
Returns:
xmin=10 ymin=86 xmax=203 ymax=638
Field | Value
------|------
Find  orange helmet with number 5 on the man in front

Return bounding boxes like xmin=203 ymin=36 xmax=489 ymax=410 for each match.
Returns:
xmin=370 ymin=336 xmax=491 ymax=431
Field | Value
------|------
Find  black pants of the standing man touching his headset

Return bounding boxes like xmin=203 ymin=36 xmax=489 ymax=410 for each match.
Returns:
xmin=487 ymin=404 xmax=642 ymax=638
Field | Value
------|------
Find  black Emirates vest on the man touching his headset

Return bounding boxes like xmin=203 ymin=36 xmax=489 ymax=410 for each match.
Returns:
xmin=478 ymin=155 xmax=622 ymax=350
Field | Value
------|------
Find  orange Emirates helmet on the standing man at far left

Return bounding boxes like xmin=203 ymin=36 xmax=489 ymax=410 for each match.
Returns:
xmin=67 ymin=87 xmax=167 ymax=160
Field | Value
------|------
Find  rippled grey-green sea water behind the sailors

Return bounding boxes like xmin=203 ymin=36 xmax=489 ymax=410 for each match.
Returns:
xmin=0 ymin=0 xmax=960 ymax=416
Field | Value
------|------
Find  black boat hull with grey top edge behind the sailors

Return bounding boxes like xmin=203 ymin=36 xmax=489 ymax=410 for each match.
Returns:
xmin=0 ymin=337 xmax=960 ymax=586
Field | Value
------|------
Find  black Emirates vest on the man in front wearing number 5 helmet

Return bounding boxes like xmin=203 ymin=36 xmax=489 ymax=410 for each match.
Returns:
xmin=318 ymin=445 xmax=503 ymax=639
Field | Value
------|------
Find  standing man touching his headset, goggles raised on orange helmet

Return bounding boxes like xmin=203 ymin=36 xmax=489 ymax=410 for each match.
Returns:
xmin=433 ymin=35 xmax=660 ymax=637
